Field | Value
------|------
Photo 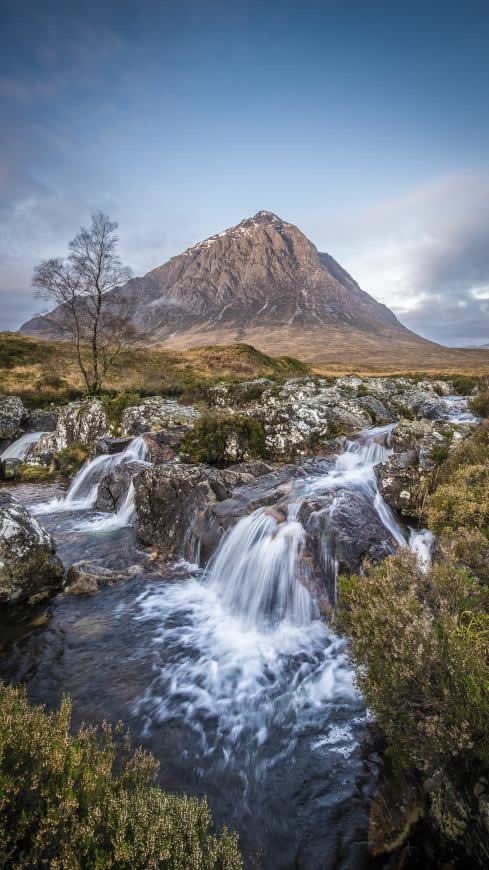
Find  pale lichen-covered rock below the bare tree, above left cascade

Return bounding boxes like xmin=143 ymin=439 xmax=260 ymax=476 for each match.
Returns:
xmin=32 ymin=399 xmax=110 ymax=456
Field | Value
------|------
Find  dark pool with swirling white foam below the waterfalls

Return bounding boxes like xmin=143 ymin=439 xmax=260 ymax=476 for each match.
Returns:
xmin=0 ymin=484 xmax=378 ymax=870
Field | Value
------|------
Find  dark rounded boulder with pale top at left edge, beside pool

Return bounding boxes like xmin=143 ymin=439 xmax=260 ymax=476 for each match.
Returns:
xmin=0 ymin=491 xmax=64 ymax=604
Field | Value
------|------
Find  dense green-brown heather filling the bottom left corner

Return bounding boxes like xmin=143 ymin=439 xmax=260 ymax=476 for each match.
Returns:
xmin=0 ymin=686 xmax=242 ymax=870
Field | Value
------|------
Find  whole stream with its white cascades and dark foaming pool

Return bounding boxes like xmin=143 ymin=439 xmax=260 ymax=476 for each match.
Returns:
xmin=0 ymin=406 xmax=470 ymax=870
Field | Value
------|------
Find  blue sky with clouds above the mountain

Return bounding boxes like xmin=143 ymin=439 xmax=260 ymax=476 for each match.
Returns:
xmin=0 ymin=0 xmax=489 ymax=346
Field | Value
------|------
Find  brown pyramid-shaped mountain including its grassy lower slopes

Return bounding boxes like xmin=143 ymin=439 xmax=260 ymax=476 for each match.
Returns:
xmin=21 ymin=211 xmax=489 ymax=365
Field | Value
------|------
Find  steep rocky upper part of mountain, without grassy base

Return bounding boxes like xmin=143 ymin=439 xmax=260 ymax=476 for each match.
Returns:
xmin=23 ymin=209 xmax=402 ymax=352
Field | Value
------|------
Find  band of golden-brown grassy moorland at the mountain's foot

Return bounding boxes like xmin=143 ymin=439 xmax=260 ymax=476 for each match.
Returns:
xmin=0 ymin=332 xmax=489 ymax=406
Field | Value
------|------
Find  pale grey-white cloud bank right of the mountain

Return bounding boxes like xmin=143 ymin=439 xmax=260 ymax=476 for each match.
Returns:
xmin=326 ymin=173 xmax=489 ymax=345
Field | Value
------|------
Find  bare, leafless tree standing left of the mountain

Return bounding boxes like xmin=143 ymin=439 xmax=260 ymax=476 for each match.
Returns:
xmin=33 ymin=212 xmax=142 ymax=395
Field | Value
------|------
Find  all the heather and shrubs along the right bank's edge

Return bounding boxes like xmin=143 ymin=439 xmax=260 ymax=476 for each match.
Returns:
xmin=337 ymin=422 xmax=489 ymax=866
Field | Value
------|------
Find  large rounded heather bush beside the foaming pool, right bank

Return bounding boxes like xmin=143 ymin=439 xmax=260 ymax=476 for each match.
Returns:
xmin=338 ymin=551 xmax=489 ymax=772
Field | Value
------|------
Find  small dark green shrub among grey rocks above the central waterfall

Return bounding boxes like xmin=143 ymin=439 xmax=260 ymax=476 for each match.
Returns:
xmin=181 ymin=414 xmax=266 ymax=468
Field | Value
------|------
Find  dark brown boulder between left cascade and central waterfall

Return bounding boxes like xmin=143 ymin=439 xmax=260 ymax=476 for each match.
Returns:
xmin=134 ymin=463 xmax=274 ymax=560
